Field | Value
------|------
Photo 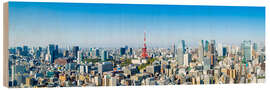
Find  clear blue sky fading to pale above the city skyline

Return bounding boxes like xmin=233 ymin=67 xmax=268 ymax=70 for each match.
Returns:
xmin=9 ymin=2 xmax=265 ymax=47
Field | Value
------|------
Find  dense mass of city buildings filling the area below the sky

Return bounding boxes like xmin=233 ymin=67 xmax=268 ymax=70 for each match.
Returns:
xmin=9 ymin=40 xmax=265 ymax=87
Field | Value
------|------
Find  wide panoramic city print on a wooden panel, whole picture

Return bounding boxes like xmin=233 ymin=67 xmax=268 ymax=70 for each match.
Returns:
xmin=4 ymin=2 xmax=266 ymax=88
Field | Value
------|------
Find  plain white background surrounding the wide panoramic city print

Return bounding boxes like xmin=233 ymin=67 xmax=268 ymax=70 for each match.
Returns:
xmin=0 ymin=0 xmax=270 ymax=90
